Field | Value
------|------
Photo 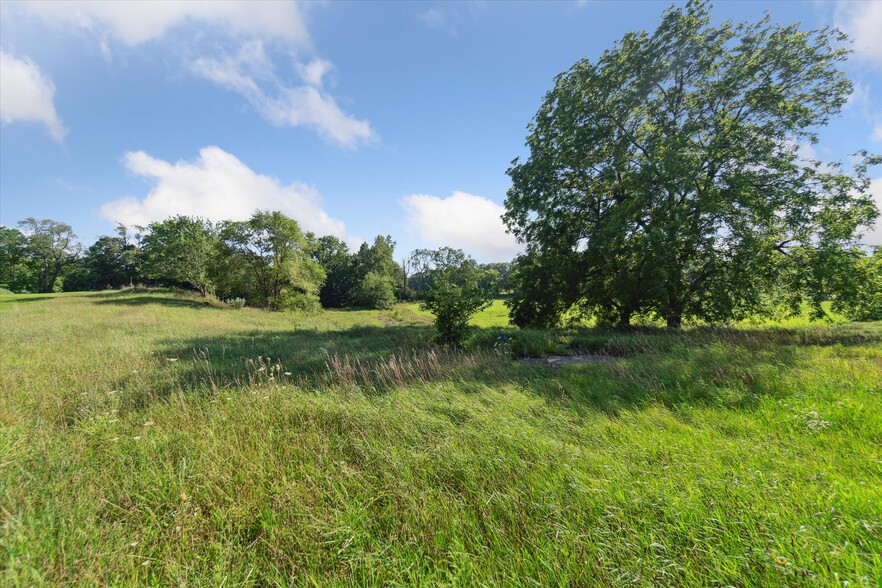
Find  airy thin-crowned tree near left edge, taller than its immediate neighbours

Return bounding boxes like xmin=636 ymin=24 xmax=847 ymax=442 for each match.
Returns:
xmin=18 ymin=217 xmax=82 ymax=293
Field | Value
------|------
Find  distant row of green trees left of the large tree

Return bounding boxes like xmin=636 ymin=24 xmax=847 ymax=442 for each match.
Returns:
xmin=0 ymin=211 xmax=510 ymax=310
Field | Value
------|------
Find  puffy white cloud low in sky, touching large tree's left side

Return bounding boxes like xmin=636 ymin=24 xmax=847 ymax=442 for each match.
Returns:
xmin=401 ymin=191 xmax=522 ymax=261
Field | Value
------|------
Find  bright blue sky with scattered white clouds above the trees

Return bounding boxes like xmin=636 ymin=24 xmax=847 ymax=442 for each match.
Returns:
xmin=0 ymin=0 xmax=882 ymax=261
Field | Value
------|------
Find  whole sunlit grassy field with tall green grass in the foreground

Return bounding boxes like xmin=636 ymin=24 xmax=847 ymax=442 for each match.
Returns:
xmin=0 ymin=291 xmax=882 ymax=586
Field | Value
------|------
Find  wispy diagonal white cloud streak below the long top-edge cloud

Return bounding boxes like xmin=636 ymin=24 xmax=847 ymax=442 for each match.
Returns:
xmin=190 ymin=41 xmax=377 ymax=149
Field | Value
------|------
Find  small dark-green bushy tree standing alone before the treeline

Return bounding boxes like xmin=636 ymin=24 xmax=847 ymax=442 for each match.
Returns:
xmin=421 ymin=259 xmax=491 ymax=344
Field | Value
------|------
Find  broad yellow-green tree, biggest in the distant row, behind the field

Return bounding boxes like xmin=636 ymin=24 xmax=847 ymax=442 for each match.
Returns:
xmin=220 ymin=211 xmax=325 ymax=310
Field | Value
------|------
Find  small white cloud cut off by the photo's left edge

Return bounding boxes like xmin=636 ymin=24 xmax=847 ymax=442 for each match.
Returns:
xmin=0 ymin=50 xmax=67 ymax=142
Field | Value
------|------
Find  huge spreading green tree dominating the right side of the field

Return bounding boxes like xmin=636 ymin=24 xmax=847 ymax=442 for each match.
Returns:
xmin=504 ymin=1 xmax=878 ymax=327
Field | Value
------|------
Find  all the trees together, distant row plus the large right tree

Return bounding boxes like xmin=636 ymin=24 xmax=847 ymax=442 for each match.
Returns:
xmin=0 ymin=0 xmax=882 ymax=330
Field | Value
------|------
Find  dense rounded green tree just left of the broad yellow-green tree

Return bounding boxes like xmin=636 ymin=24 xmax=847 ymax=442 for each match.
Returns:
xmin=143 ymin=215 xmax=217 ymax=296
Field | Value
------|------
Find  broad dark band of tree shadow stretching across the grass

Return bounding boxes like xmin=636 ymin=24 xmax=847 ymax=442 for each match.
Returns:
xmin=110 ymin=322 xmax=882 ymax=415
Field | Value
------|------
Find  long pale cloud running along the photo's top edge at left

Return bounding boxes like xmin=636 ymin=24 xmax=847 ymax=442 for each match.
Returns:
xmin=22 ymin=0 xmax=309 ymax=47
